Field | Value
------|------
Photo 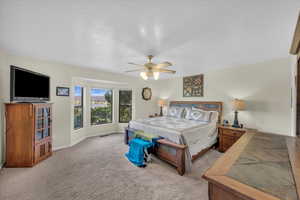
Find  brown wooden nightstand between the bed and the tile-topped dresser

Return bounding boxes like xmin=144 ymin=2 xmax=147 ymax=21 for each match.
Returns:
xmin=218 ymin=126 xmax=247 ymax=152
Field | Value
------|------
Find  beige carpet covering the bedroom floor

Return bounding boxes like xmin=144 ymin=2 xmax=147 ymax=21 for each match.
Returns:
xmin=0 ymin=134 xmax=220 ymax=200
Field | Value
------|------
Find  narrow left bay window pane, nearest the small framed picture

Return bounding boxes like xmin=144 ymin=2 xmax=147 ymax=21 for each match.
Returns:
xmin=74 ymin=86 xmax=83 ymax=129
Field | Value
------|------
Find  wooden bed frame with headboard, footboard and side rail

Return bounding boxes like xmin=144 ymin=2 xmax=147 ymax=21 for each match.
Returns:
xmin=125 ymin=101 xmax=222 ymax=176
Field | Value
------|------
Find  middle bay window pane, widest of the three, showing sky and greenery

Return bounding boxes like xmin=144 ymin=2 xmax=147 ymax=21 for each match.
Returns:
xmin=91 ymin=88 xmax=113 ymax=125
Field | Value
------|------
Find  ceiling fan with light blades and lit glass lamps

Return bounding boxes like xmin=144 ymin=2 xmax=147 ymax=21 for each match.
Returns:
xmin=125 ymin=55 xmax=176 ymax=80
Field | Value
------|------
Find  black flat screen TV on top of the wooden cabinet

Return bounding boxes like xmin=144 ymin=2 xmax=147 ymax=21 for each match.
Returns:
xmin=10 ymin=66 xmax=50 ymax=102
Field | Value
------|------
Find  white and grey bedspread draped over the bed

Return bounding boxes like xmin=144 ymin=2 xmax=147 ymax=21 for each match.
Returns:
xmin=129 ymin=117 xmax=217 ymax=172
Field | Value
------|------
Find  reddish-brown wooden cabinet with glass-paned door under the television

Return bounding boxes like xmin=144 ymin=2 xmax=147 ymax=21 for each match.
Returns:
xmin=5 ymin=103 xmax=52 ymax=167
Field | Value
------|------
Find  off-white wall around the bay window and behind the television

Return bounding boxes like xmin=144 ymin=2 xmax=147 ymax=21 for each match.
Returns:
xmin=0 ymin=51 xmax=158 ymax=166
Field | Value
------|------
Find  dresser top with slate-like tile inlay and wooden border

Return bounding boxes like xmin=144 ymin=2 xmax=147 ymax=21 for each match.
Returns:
xmin=203 ymin=132 xmax=300 ymax=200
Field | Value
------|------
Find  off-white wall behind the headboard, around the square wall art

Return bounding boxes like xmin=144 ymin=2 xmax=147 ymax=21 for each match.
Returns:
xmin=154 ymin=58 xmax=292 ymax=135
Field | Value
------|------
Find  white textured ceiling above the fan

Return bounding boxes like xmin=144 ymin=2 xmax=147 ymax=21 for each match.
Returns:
xmin=0 ymin=0 xmax=300 ymax=76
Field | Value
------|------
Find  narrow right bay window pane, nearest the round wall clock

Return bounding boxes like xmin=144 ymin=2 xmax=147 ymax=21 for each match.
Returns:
xmin=119 ymin=90 xmax=132 ymax=123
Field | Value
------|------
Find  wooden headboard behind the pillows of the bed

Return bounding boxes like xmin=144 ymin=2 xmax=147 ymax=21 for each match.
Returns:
xmin=170 ymin=101 xmax=223 ymax=123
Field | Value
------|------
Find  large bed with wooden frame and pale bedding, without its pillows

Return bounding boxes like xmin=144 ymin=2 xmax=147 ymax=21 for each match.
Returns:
xmin=125 ymin=101 xmax=222 ymax=175
